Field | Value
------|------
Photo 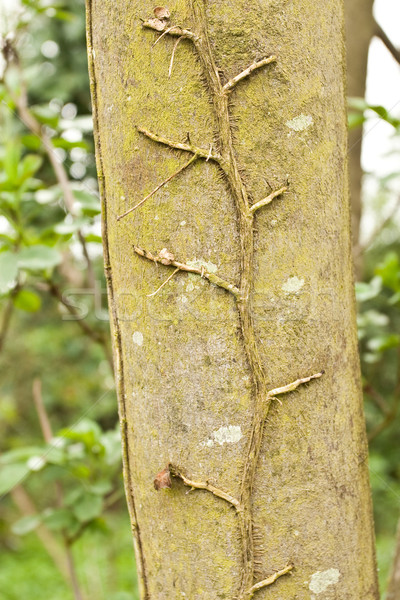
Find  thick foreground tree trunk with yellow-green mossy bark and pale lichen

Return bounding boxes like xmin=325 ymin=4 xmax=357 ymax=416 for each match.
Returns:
xmin=88 ymin=0 xmax=378 ymax=600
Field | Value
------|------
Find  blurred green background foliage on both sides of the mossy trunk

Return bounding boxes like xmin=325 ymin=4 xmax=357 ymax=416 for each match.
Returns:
xmin=0 ymin=0 xmax=400 ymax=600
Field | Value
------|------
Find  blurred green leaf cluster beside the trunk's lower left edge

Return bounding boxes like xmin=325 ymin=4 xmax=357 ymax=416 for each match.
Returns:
xmin=0 ymin=418 xmax=122 ymax=543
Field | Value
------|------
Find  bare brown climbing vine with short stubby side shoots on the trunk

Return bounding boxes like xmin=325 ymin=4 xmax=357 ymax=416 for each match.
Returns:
xmin=117 ymin=0 xmax=323 ymax=600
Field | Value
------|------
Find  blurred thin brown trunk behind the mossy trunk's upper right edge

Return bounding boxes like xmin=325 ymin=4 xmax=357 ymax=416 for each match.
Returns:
xmin=344 ymin=0 xmax=375 ymax=280
